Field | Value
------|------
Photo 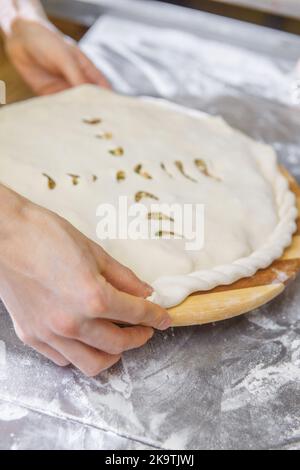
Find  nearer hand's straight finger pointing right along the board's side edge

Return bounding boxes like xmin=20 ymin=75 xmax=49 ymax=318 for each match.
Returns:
xmin=91 ymin=278 xmax=171 ymax=330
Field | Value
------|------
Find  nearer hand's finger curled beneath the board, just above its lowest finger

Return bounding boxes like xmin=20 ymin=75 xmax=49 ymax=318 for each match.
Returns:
xmin=77 ymin=319 xmax=154 ymax=354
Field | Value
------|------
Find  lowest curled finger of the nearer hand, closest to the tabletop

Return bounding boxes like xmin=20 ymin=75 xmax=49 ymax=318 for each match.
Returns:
xmin=51 ymin=336 xmax=121 ymax=377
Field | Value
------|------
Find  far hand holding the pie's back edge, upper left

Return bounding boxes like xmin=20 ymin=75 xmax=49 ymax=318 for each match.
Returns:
xmin=5 ymin=18 xmax=109 ymax=95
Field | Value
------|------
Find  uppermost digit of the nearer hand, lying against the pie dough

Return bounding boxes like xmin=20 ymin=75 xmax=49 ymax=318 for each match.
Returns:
xmin=92 ymin=244 xmax=153 ymax=298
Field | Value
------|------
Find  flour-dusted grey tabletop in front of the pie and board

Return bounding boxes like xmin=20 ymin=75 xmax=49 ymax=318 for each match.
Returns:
xmin=0 ymin=282 xmax=300 ymax=450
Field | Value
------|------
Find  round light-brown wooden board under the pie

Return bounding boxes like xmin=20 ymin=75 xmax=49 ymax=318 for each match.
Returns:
xmin=169 ymin=169 xmax=300 ymax=326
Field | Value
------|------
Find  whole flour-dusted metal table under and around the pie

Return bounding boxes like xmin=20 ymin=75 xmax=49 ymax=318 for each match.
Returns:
xmin=0 ymin=0 xmax=300 ymax=450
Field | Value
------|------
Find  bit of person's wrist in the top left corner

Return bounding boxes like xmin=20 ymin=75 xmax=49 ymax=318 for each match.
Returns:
xmin=0 ymin=0 xmax=47 ymax=35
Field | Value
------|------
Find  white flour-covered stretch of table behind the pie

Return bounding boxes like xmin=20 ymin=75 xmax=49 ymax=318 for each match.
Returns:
xmin=82 ymin=12 xmax=299 ymax=103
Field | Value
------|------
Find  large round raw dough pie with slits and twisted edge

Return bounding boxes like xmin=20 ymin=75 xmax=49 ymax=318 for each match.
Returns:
xmin=0 ymin=85 xmax=297 ymax=307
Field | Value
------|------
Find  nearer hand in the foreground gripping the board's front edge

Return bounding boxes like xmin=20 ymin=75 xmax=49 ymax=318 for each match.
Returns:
xmin=0 ymin=187 xmax=171 ymax=376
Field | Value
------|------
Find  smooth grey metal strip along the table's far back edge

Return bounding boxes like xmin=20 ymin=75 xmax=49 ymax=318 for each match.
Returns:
xmin=42 ymin=0 xmax=300 ymax=61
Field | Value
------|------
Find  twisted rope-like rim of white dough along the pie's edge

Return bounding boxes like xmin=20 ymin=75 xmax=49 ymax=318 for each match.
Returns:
xmin=144 ymin=97 xmax=298 ymax=308
